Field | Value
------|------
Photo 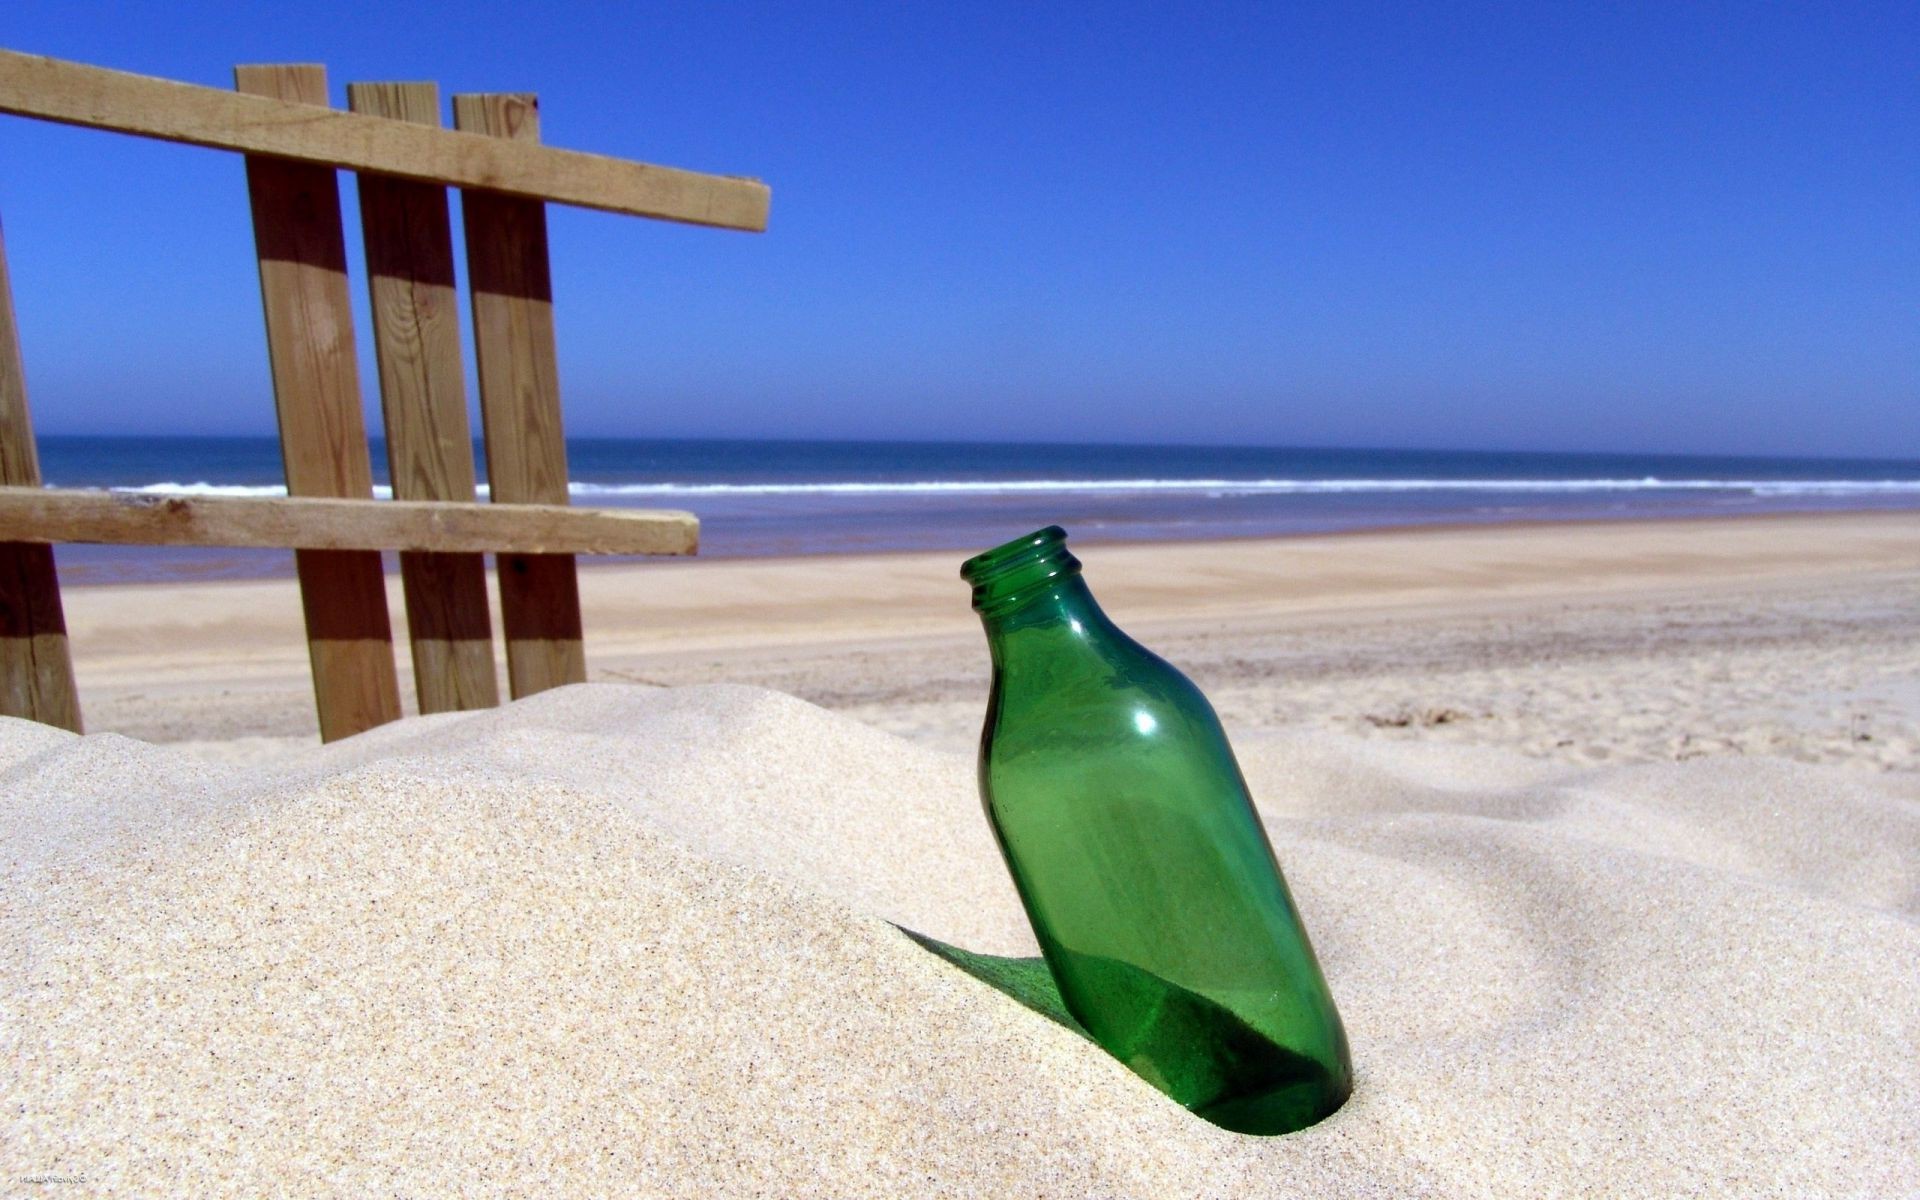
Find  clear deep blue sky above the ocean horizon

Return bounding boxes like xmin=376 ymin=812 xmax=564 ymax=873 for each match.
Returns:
xmin=0 ymin=0 xmax=1920 ymax=457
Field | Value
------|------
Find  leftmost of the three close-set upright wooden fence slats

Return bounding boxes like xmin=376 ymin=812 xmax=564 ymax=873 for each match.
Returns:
xmin=234 ymin=65 xmax=399 ymax=741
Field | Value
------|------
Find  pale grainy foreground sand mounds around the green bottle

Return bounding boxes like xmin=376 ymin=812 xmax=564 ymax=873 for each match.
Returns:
xmin=0 ymin=685 xmax=1920 ymax=1198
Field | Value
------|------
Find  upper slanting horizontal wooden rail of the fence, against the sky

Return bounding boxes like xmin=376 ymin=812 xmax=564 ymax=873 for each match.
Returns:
xmin=0 ymin=50 xmax=770 ymax=232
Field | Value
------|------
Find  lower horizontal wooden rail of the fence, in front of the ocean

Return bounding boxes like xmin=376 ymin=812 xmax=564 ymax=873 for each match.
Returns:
xmin=0 ymin=488 xmax=699 ymax=557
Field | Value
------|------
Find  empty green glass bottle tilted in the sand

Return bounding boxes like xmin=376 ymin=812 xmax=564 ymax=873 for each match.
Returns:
xmin=960 ymin=526 xmax=1354 ymax=1133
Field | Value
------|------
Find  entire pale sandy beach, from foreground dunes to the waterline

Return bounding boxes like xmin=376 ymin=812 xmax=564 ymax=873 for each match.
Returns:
xmin=0 ymin=513 xmax=1920 ymax=1196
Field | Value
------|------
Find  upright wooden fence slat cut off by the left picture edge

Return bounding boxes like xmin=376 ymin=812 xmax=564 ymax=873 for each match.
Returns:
xmin=0 ymin=213 xmax=81 ymax=733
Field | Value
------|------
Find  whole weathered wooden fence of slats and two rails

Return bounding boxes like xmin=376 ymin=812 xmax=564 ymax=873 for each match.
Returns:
xmin=0 ymin=50 xmax=768 ymax=741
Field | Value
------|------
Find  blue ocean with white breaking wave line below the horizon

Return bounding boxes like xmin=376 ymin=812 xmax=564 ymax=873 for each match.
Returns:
xmin=40 ymin=436 xmax=1920 ymax=584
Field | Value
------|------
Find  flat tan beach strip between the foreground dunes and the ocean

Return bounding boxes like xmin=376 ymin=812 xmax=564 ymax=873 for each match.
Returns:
xmin=56 ymin=513 xmax=1920 ymax=770
